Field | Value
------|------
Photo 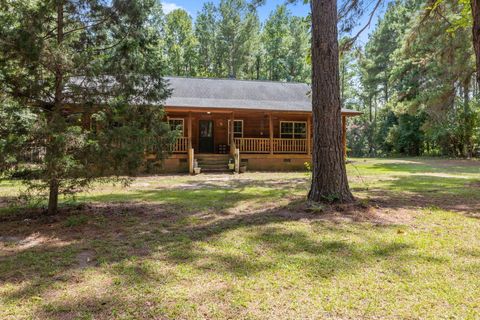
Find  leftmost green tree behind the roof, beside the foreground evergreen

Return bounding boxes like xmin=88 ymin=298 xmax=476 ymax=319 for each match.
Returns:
xmin=165 ymin=9 xmax=197 ymax=76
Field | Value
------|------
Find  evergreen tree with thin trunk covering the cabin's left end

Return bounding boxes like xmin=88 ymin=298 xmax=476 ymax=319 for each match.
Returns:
xmin=0 ymin=0 xmax=176 ymax=214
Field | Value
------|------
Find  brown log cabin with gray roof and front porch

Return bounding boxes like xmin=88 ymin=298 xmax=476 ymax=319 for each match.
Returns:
xmin=163 ymin=77 xmax=360 ymax=173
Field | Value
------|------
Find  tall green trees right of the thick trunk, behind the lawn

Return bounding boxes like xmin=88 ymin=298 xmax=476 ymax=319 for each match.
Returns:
xmin=341 ymin=0 xmax=480 ymax=157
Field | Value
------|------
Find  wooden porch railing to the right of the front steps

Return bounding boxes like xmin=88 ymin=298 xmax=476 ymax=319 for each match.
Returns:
xmin=234 ymin=138 xmax=307 ymax=153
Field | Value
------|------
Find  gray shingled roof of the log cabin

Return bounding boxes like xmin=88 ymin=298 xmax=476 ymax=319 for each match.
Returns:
xmin=165 ymin=77 xmax=358 ymax=113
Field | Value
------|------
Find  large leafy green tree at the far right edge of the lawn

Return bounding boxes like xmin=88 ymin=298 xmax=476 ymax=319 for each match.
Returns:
xmin=392 ymin=3 xmax=476 ymax=157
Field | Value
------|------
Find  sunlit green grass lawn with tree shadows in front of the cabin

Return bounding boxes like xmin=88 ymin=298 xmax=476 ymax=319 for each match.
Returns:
xmin=0 ymin=158 xmax=480 ymax=319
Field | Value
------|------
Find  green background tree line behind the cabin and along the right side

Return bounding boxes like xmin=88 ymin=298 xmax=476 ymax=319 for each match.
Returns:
xmin=161 ymin=0 xmax=480 ymax=157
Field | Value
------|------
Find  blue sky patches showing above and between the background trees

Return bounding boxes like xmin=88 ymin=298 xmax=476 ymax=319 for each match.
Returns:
xmin=162 ymin=0 xmax=391 ymax=45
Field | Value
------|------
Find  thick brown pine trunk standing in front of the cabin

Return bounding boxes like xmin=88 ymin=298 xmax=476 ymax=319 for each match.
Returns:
xmin=308 ymin=0 xmax=354 ymax=202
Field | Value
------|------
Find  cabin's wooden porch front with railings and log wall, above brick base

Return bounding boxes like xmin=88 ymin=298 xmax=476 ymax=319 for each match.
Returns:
xmin=167 ymin=108 xmax=347 ymax=156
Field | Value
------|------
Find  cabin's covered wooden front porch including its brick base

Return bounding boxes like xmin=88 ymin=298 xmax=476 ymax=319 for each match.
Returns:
xmin=166 ymin=107 xmax=348 ymax=173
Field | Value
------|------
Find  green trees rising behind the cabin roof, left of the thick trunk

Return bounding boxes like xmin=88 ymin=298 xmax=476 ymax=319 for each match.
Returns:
xmin=161 ymin=0 xmax=311 ymax=82
